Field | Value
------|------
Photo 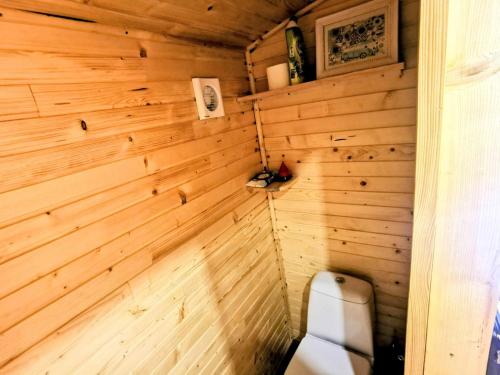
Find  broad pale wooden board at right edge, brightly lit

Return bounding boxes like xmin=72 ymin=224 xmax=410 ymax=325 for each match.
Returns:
xmin=424 ymin=0 xmax=500 ymax=375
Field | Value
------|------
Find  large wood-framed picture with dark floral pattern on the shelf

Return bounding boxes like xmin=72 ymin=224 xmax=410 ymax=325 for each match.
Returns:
xmin=316 ymin=0 xmax=398 ymax=78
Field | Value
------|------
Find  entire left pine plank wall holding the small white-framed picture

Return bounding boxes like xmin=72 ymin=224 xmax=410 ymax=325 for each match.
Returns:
xmin=0 ymin=8 xmax=289 ymax=374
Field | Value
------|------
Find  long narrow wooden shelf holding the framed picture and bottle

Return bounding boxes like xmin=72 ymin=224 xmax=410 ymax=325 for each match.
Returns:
xmin=237 ymin=62 xmax=405 ymax=103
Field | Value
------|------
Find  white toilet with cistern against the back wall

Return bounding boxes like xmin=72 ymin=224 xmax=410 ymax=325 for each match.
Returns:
xmin=285 ymin=272 xmax=375 ymax=375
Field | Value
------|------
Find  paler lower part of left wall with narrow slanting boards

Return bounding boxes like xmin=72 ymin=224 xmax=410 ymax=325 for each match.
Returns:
xmin=4 ymin=198 xmax=288 ymax=374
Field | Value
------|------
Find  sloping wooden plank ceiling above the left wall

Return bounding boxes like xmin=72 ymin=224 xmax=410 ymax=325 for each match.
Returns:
xmin=0 ymin=0 xmax=310 ymax=47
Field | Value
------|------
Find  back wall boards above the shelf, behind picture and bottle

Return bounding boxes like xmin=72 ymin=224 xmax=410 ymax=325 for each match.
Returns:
xmin=251 ymin=0 xmax=420 ymax=92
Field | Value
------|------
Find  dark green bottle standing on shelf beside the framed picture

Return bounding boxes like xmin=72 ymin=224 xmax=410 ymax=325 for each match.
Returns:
xmin=285 ymin=16 xmax=306 ymax=85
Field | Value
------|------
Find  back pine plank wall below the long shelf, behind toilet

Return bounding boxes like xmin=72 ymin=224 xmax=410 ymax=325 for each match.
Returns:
xmin=255 ymin=64 xmax=416 ymax=345
